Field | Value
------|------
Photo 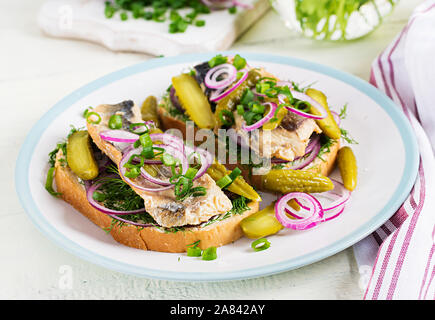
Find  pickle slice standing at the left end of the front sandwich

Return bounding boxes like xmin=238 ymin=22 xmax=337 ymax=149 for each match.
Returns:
xmin=66 ymin=130 xmax=98 ymax=180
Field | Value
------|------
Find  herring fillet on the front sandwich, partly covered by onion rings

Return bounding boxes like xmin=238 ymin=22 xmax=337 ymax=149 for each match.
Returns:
xmin=87 ymin=100 xmax=232 ymax=228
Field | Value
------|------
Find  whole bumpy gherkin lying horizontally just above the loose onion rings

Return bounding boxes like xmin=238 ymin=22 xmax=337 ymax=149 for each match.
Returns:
xmin=261 ymin=169 xmax=334 ymax=193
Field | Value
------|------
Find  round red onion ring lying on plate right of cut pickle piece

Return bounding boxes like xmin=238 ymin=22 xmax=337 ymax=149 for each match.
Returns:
xmin=275 ymin=192 xmax=323 ymax=230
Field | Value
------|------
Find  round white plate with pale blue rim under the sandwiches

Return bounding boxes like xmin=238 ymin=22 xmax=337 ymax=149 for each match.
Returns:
xmin=16 ymin=53 xmax=418 ymax=281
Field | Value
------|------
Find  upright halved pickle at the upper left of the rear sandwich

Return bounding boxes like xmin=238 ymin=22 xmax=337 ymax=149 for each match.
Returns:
xmin=172 ymin=73 xmax=214 ymax=129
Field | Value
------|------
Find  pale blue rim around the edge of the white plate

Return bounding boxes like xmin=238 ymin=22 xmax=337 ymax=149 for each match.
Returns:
xmin=15 ymin=51 xmax=419 ymax=281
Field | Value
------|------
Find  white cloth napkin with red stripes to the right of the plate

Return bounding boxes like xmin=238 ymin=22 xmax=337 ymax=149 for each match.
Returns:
xmin=353 ymin=0 xmax=435 ymax=300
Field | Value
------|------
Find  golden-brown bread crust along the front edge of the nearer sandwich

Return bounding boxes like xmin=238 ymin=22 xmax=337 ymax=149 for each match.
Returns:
xmin=55 ymin=150 xmax=259 ymax=252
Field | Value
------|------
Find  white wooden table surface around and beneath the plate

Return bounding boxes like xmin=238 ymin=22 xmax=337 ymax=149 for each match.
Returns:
xmin=0 ymin=0 xmax=422 ymax=299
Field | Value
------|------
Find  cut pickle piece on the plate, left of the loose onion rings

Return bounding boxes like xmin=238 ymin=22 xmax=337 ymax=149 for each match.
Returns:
xmin=240 ymin=203 xmax=284 ymax=239
